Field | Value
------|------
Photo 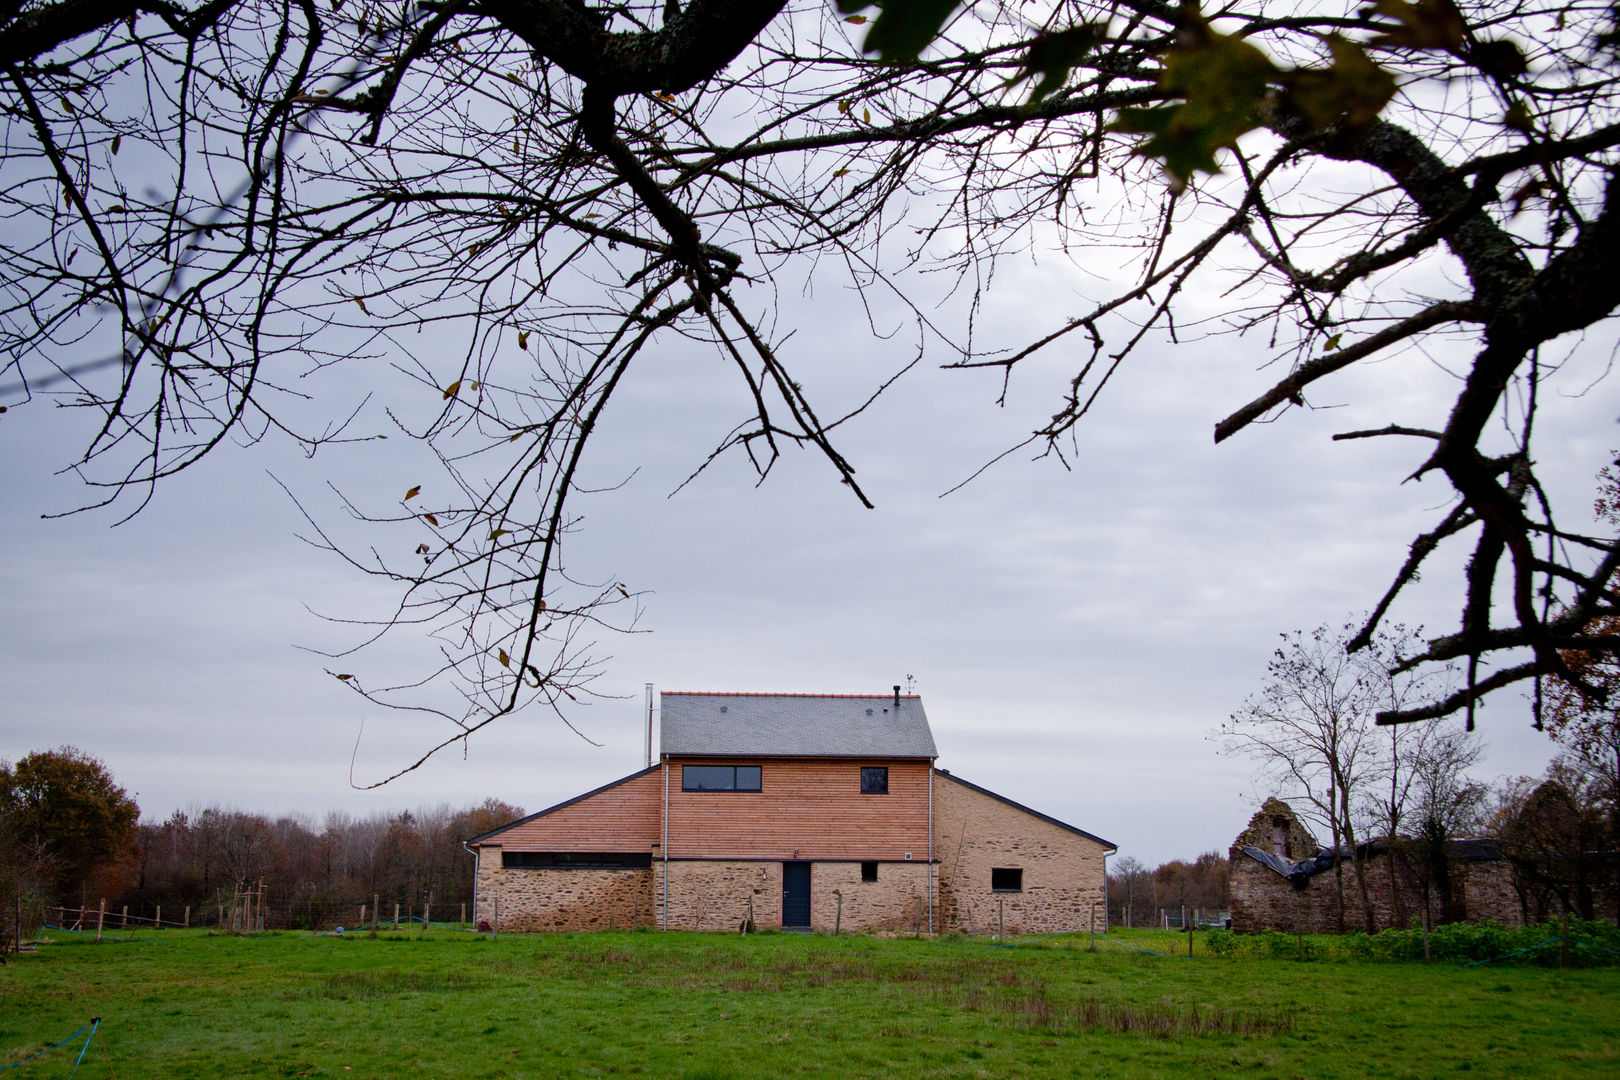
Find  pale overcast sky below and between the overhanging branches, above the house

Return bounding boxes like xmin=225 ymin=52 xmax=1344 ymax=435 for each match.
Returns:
xmin=0 ymin=153 xmax=1617 ymax=865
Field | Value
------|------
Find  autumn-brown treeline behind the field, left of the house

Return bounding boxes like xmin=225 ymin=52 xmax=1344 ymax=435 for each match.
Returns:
xmin=0 ymin=746 xmax=523 ymax=929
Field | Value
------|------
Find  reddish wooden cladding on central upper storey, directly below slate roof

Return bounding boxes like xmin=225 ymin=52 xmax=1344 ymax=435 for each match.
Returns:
xmin=669 ymin=758 xmax=930 ymax=861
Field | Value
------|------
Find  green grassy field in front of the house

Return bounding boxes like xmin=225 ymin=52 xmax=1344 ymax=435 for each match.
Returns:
xmin=0 ymin=928 xmax=1620 ymax=1080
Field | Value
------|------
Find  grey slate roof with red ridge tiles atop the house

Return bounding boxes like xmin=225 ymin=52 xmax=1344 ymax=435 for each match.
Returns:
xmin=659 ymin=691 xmax=940 ymax=758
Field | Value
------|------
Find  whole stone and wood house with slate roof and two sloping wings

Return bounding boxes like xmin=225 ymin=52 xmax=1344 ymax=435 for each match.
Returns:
xmin=467 ymin=687 xmax=1115 ymax=933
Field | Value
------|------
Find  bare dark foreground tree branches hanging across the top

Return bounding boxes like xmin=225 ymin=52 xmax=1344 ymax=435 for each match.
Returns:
xmin=0 ymin=0 xmax=1620 ymax=773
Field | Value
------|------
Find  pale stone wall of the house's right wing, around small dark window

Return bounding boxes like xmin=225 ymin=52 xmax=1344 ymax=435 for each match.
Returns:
xmin=935 ymin=774 xmax=1108 ymax=934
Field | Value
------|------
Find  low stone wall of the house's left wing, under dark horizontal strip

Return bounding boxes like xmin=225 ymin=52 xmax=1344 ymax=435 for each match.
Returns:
xmin=476 ymin=848 xmax=654 ymax=931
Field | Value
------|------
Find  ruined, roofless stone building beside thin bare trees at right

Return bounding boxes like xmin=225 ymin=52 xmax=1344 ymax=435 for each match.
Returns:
xmin=1230 ymin=798 xmax=1524 ymax=934
